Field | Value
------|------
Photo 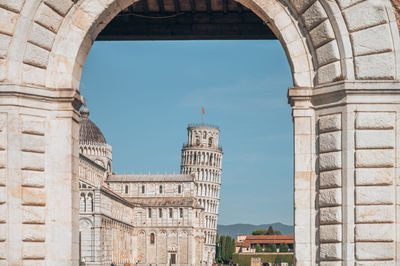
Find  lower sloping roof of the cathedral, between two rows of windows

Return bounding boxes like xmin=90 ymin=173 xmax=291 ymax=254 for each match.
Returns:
xmin=125 ymin=197 xmax=198 ymax=207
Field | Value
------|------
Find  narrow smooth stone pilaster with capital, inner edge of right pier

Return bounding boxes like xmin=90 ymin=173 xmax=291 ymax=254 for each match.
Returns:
xmin=288 ymin=87 xmax=316 ymax=266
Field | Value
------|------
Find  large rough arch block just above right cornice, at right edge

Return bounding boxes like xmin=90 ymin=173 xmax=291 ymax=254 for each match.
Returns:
xmin=354 ymin=52 xmax=395 ymax=80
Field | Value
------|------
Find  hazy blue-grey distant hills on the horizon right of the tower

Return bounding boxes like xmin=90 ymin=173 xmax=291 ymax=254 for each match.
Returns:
xmin=218 ymin=223 xmax=294 ymax=238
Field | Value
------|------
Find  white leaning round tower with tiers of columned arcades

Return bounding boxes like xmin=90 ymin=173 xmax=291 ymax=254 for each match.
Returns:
xmin=181 ymin=124 xmax=222 ymax=265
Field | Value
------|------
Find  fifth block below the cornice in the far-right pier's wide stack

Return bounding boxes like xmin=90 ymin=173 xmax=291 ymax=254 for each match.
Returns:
xmin=355 ymin=186 xmax=395 ymax=205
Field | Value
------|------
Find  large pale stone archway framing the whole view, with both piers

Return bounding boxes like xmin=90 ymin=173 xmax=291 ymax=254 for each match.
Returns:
xmin=0 ymin=0 xmax=400 ymax=265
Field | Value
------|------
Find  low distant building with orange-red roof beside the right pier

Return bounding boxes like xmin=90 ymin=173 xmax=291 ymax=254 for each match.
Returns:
xmin=236 ymin=235 xmax=294 ymax=254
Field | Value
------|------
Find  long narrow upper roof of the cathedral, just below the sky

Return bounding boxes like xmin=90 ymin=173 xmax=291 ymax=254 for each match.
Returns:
xmin=107 ymin=174 xmax=194 ymax=182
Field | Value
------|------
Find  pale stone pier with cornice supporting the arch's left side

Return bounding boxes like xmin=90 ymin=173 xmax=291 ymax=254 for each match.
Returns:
xmin=0 ymin=84 xmax=80 ymax=265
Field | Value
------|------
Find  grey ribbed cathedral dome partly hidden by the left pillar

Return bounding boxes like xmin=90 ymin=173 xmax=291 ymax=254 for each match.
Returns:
xmin=79 ymin=107 xmax=107 ymax=144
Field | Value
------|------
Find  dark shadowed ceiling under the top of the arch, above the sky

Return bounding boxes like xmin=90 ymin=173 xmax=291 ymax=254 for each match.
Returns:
xmin=97 ymin=0 xmax=277 ymax=41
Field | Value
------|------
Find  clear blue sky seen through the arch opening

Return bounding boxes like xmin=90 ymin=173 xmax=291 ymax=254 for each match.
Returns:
xmin=80 ymin=41 xmax=293 ymax=224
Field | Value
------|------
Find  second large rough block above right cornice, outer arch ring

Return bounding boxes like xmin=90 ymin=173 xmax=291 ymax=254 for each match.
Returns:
xmin=350 ymin=24 xmax=393 ymax=56
